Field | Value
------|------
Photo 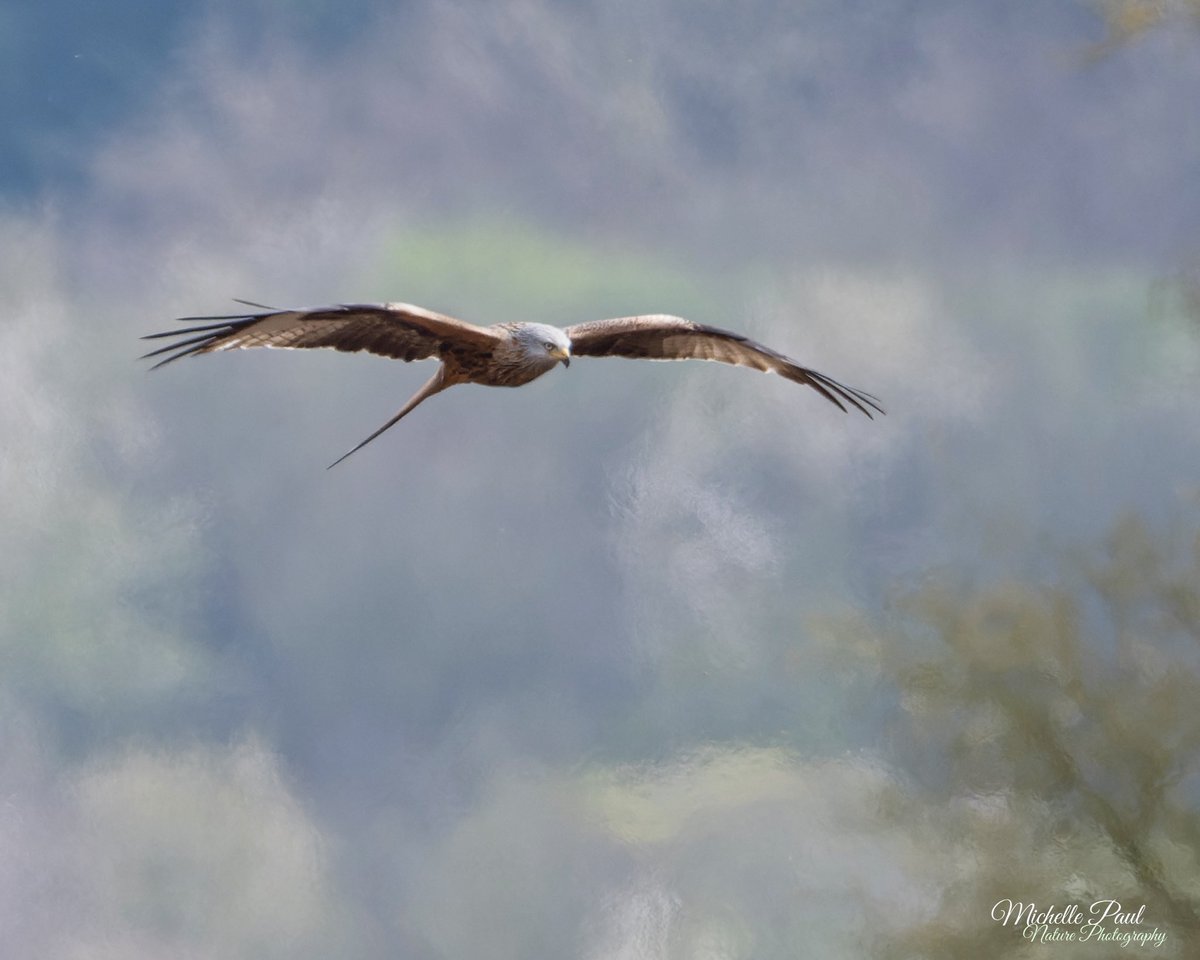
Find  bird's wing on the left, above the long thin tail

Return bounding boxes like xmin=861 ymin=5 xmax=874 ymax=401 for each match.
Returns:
xmin=142 ymin=304 xmax=503 ymax=367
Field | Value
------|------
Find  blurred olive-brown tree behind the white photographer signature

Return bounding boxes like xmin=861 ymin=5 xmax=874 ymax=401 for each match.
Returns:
xmin=829 ymin=518 xmax=1200 ymax=958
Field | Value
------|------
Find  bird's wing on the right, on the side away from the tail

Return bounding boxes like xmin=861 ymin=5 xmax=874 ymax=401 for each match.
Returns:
xmin=566 ymin=314 xmax=883 ymax=416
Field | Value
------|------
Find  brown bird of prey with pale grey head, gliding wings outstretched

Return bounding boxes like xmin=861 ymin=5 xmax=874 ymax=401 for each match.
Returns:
xmin=142 ymin=300 xmax=883 ymax=467
